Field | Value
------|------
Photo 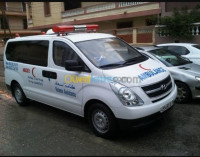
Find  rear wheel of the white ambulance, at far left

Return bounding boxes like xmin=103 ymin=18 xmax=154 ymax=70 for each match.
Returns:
xmin=12 ymin=83 xmax=29 ymax=106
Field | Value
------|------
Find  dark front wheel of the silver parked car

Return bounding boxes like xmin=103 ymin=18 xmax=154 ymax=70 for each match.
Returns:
xmin=175 ymin=82 xmax=191 ymax=103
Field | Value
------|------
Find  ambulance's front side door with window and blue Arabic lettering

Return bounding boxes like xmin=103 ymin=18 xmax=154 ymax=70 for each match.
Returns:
xmin=47 ymin=40 xmax=88 ymax=115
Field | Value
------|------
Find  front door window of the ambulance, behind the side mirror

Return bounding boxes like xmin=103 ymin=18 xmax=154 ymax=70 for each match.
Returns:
xmin=53 ymin=41 xmax=81 ymax=67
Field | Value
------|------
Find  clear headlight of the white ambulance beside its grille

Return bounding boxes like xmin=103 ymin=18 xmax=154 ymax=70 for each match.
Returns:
xmin=110 ymin=82 xmax=144 ymax=107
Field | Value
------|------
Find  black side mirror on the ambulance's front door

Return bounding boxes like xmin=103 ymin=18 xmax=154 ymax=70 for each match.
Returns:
xmin=65 ymin=60 xmax=84 ymax=71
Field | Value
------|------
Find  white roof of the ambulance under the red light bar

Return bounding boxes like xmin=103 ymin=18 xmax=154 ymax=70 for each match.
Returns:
xmin=7 ymin=33 xmax=114 ymax=42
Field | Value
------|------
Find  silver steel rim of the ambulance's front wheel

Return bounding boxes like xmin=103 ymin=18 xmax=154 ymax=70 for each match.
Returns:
xmin=92 ymin=110 xmax=109 ymax=133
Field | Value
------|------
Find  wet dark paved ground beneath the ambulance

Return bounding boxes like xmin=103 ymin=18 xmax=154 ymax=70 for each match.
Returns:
xmin=0 ymin=77 xmax=200 ymax=156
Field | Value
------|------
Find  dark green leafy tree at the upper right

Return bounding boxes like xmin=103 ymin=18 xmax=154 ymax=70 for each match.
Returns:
xmin=159 ymin=5 xmax=200 ymax=40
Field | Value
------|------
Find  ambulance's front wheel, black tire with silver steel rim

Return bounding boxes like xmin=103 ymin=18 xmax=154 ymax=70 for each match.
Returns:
xmin=87 ymin=103 xmax=117 ymax=139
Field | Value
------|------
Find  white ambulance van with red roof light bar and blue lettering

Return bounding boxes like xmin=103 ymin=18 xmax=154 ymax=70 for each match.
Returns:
xmin=4 ymin=25 xmax=177 ymax=138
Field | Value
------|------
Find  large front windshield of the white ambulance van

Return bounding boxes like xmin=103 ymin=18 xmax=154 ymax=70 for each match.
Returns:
xmin=76 ymin=38 xmax=148 ymax=68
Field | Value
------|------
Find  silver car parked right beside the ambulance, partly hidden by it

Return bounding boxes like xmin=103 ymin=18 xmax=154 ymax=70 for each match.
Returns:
xmin=135 ymin=46 xmax=200 ymax=103
